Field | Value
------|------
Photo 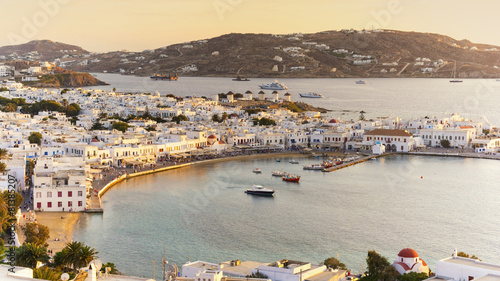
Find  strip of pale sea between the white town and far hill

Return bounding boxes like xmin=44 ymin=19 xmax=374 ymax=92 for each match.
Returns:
xmin=91 ymin=73 xmax=500 ymax=125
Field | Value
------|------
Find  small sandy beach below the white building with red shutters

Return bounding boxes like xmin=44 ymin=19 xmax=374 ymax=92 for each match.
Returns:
xmin=19 ymin=212 xmax=85 ymax=253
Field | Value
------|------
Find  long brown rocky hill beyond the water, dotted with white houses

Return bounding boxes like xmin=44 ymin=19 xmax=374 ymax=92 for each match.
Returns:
xmin=2 ymin=30 xmax=500 ymax=78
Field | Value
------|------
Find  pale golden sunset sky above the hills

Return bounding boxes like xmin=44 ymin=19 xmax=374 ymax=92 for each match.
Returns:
xmin=0 ymin=0 xmax=500 ymax=52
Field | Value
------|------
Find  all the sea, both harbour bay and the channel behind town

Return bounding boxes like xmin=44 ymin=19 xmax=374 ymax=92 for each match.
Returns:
xmin=73 ymin=74 xmax=500 ymax=280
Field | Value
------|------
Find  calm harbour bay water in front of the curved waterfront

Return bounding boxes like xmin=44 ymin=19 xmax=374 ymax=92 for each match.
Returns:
xmin=74 ymin=156 xmax=500 ymax=280
